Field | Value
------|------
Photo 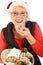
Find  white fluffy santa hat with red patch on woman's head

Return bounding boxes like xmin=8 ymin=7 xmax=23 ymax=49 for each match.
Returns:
xmin=7 ymin=0 xmax=29 ymax=12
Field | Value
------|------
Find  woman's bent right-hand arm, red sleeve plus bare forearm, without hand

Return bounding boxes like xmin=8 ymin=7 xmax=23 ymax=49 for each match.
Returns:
xmin=27 ymin=23 xmax=43 ymax=57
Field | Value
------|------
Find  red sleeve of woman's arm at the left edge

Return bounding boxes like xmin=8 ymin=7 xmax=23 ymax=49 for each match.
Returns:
xmin=0 ymin=32 xmax=7 ymax=63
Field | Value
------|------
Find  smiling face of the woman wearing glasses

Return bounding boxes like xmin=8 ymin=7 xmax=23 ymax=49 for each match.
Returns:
xmin=10 ymin=6 xmax=28 ymax=26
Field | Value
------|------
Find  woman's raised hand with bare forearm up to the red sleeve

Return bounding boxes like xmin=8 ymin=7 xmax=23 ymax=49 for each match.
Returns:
xmin=16 ymin=27 xmax=36 ymax=45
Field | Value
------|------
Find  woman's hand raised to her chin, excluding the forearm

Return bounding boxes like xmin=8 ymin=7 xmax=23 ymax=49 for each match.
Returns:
xmin=16 ymin=27 xmax=31 ymax=39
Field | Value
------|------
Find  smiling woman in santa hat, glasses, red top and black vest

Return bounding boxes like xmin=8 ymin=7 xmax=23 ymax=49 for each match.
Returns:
xmin=0 ymin=1 xmax=43 ymax=65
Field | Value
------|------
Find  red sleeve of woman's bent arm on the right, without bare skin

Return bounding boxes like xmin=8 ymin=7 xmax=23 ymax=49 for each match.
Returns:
xmin=32 ymin=23 xmax=43 ymax=57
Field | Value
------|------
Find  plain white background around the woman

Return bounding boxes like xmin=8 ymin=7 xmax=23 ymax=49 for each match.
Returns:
xmin=0 ymin=0 xmax=43 ymax=65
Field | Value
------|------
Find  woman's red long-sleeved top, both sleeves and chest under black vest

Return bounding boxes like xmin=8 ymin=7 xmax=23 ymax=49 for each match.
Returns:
xmin=0 ymin=23 xmax=43 ymax=62
